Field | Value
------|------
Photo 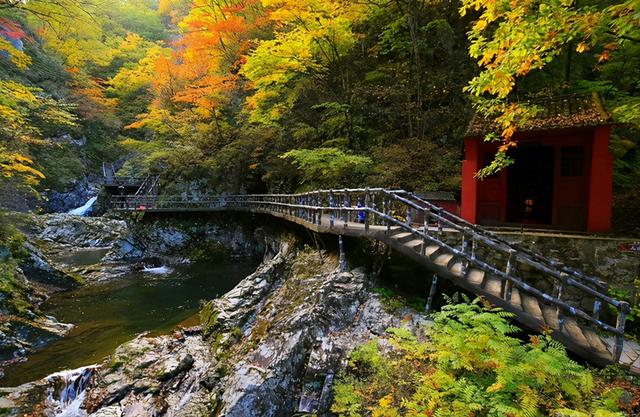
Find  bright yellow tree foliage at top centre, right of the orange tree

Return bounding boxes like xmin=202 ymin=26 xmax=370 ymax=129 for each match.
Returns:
xmin=241 ymin=0 xmax=367 ymax=124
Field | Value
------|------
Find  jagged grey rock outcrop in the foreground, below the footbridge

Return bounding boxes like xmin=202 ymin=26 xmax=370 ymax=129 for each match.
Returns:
xmin=0 ymin=231 xmax=424 ymax=417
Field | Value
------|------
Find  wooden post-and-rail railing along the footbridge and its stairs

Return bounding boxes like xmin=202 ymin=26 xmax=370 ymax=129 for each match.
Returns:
xmin=112 ymin=188 xmax=630 ymax=361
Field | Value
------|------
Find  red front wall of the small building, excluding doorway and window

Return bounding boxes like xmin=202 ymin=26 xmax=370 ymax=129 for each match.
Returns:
xmin=461 ymin=126 xmax=613 ymax=232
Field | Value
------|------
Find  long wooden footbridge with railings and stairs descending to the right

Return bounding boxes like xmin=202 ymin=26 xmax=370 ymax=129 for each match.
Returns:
xmin=112 ymin=189 xmax=640 ymax=374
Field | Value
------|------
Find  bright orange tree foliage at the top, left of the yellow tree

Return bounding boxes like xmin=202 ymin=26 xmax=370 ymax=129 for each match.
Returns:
xmin=141 ymin=0 xmax=263 ymax=128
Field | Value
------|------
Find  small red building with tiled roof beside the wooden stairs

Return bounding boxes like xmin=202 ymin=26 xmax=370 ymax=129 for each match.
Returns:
xmin=461 ymin=96 xmax=613 ymax=232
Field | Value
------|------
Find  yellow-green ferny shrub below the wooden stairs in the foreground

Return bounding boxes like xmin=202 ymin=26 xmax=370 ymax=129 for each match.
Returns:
xmin=332 ymin=300 xmax=623 ymax=417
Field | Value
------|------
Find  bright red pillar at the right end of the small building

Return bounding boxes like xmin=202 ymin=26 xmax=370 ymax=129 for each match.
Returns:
xmin=587 ymin=126 xmax=613 ymax=233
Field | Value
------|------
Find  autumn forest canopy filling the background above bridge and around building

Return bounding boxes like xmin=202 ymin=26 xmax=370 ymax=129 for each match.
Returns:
xmin=0 ymin=0 xmax=640 ymax=221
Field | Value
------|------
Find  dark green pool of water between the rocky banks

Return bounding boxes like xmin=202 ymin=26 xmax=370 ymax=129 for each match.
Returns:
xmin=0 ymin=255 xmax=256 ymax=386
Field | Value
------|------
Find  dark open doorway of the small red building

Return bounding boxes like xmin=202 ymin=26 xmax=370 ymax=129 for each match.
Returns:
xmin=507 ymin=146 xmax=555 ymax=224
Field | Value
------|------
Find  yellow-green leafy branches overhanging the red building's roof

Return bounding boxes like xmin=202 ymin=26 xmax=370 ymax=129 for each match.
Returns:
xmin=460 ymin=0 xmax=640 ymax=175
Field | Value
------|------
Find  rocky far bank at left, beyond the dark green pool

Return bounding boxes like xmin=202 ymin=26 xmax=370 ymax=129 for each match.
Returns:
xmin=0 ymin=213 xmax=263 ymax=374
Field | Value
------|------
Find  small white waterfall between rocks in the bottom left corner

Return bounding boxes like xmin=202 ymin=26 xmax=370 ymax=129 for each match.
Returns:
xmin=47 ymin=366 xmax=95 ymax=417
